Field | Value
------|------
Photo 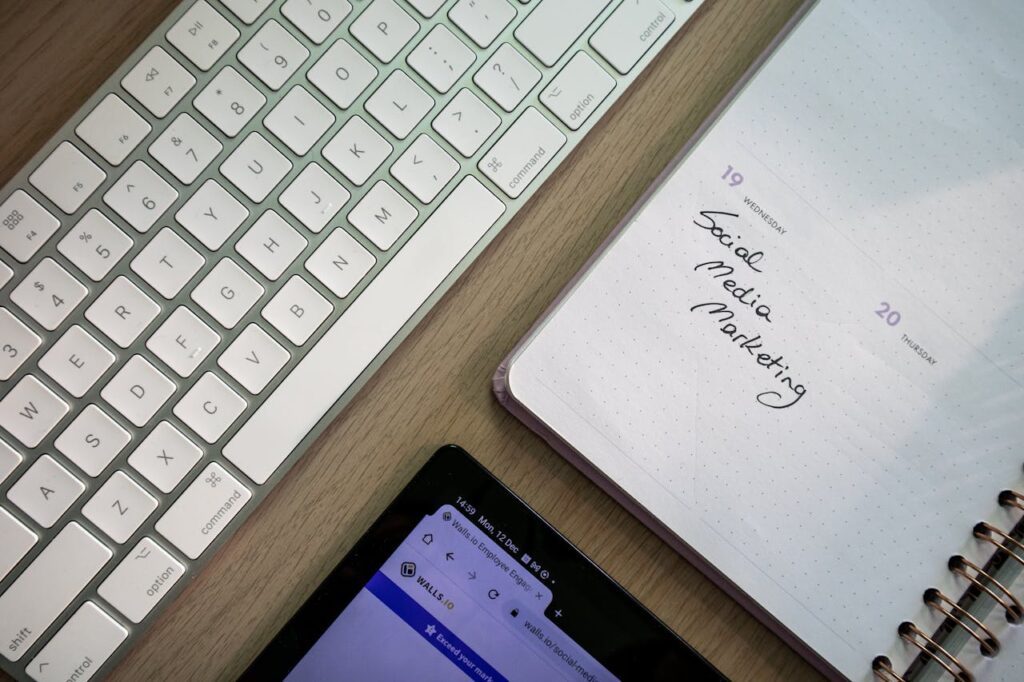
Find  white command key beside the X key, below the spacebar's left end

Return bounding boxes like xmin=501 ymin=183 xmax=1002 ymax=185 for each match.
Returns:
xmin=157 ymin=464 xmax=252 ymax=559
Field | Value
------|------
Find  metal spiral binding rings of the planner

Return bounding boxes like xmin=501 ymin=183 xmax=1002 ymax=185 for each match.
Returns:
xmin=871 ymin=491 xmax=1024 ymax=682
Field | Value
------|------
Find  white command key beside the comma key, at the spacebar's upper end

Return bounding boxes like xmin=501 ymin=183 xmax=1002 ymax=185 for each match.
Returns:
xmin=477 ymin=106 xmax=565 ymax=199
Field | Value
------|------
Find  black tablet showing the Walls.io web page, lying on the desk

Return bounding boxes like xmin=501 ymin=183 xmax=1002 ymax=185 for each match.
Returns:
xmin=243 ymin=445 xmax=724 ymax=682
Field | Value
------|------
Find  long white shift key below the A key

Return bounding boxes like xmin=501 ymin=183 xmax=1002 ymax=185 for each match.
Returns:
xmin=0 ymin=521 xmax=113 ymax=660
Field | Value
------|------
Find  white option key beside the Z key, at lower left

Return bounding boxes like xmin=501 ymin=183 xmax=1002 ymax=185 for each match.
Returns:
xmin=96 ymin=538 xmax=186 ymax=623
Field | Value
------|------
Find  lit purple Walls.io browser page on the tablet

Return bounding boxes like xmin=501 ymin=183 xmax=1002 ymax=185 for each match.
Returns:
xmin=278 ymin=506 xmax=615 ymax=682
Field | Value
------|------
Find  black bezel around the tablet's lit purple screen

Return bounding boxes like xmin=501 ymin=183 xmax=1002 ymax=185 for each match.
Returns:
xmin=241 ymin=445 xmax=725 ymax=680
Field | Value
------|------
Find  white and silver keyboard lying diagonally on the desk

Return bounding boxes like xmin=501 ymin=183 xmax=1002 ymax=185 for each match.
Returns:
xmin=0 ymin=0 xmax=700 ymax=681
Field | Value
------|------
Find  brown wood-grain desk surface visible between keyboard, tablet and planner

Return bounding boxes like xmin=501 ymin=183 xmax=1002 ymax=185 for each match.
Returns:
xmin=0 ymin=0 xmax=816 ymax=680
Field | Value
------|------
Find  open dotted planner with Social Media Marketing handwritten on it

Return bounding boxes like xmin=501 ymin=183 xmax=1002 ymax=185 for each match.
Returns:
xmin=496 ymin=0 xmax=1024 ymax=681
